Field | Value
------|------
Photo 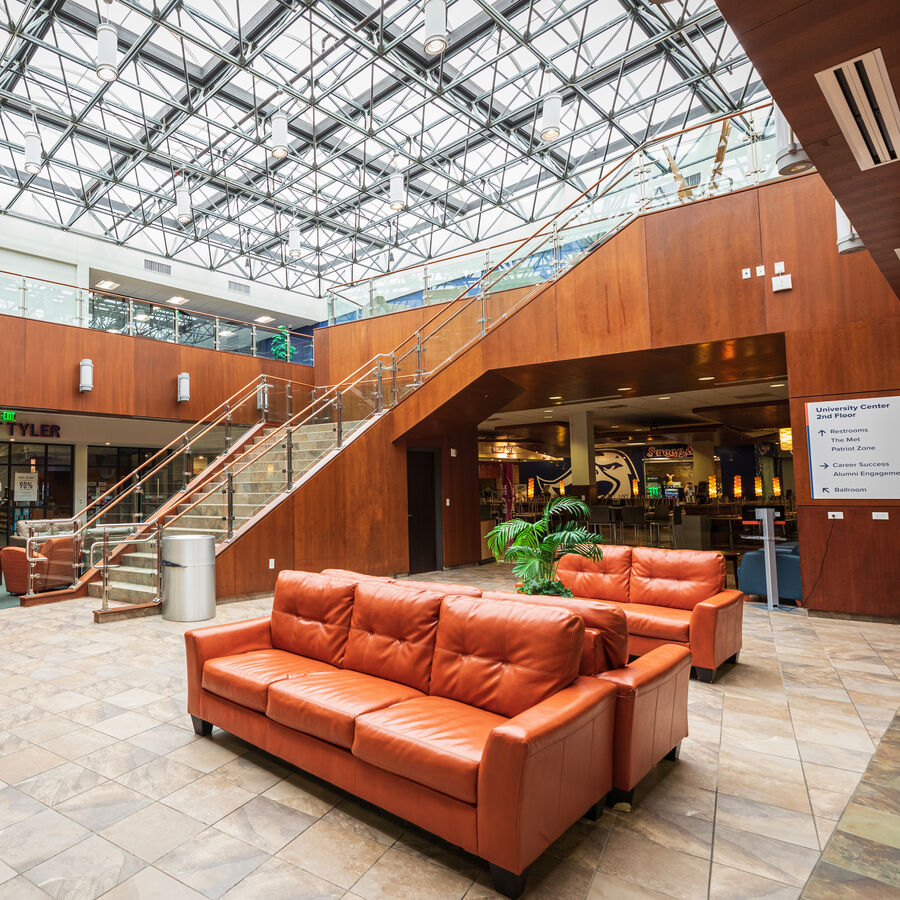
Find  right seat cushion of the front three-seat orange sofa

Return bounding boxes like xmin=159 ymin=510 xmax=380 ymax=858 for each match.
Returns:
xmin=352 ymin=697 xmax=506 ymax=803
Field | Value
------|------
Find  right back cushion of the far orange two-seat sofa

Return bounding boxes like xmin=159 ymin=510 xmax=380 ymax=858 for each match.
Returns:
xmin=631 ymin=547 xmax=725 ymax=609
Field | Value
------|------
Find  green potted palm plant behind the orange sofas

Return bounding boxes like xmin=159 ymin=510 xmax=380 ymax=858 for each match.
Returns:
xmin=486 ymin=497 xmax=603 ymax=597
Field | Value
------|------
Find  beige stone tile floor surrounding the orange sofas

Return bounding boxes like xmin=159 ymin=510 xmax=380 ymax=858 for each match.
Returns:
xmin=0 ymin=566 xmax=900 ymax=900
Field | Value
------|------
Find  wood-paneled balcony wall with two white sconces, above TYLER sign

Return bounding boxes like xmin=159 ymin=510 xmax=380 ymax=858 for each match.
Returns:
xmin=0 ymin=316 xmax=313 ymax=421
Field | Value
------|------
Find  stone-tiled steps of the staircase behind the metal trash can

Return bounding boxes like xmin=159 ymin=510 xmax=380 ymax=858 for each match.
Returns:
xmin=88 ymin=422 xmax=360 ymax=604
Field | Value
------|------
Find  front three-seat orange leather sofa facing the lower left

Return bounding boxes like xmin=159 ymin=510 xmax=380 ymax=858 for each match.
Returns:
xmin=185 ymin=572 xmax=616 ymax=896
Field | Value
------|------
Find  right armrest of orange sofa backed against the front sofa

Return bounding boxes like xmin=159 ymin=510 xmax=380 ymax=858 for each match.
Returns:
xmin=598 ymin=644 xmax=691 ymax=791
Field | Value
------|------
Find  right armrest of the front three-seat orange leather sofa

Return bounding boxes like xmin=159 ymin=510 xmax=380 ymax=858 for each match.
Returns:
xmin=477 ymin=677 xmax=615 ymax=873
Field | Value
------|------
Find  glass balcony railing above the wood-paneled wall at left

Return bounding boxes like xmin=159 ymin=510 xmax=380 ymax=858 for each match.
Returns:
xmin=0 ymin=271 xmax=313 ymax=366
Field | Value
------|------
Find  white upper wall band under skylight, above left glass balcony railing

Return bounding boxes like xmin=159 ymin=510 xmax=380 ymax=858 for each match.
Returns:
xmin=0 ymin=216 xmax=326 ymax=322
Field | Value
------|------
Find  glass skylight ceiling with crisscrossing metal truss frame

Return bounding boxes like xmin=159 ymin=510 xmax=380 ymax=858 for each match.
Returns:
xmin=0 ymin=0 xmax=768 ymax=297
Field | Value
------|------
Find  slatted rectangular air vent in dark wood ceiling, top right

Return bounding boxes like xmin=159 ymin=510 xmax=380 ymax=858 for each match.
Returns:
xmin=816 ymin=50 xmax=900 ymax=169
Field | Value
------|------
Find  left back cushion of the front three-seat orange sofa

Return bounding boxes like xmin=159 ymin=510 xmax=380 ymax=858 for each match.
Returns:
xmin=272 ymin=570 xmax=355 ymax=666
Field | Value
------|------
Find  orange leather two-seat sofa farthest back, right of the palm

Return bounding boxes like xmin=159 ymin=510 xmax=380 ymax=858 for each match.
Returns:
xmin=557 ymin=545 xmax=744 ymax=683
